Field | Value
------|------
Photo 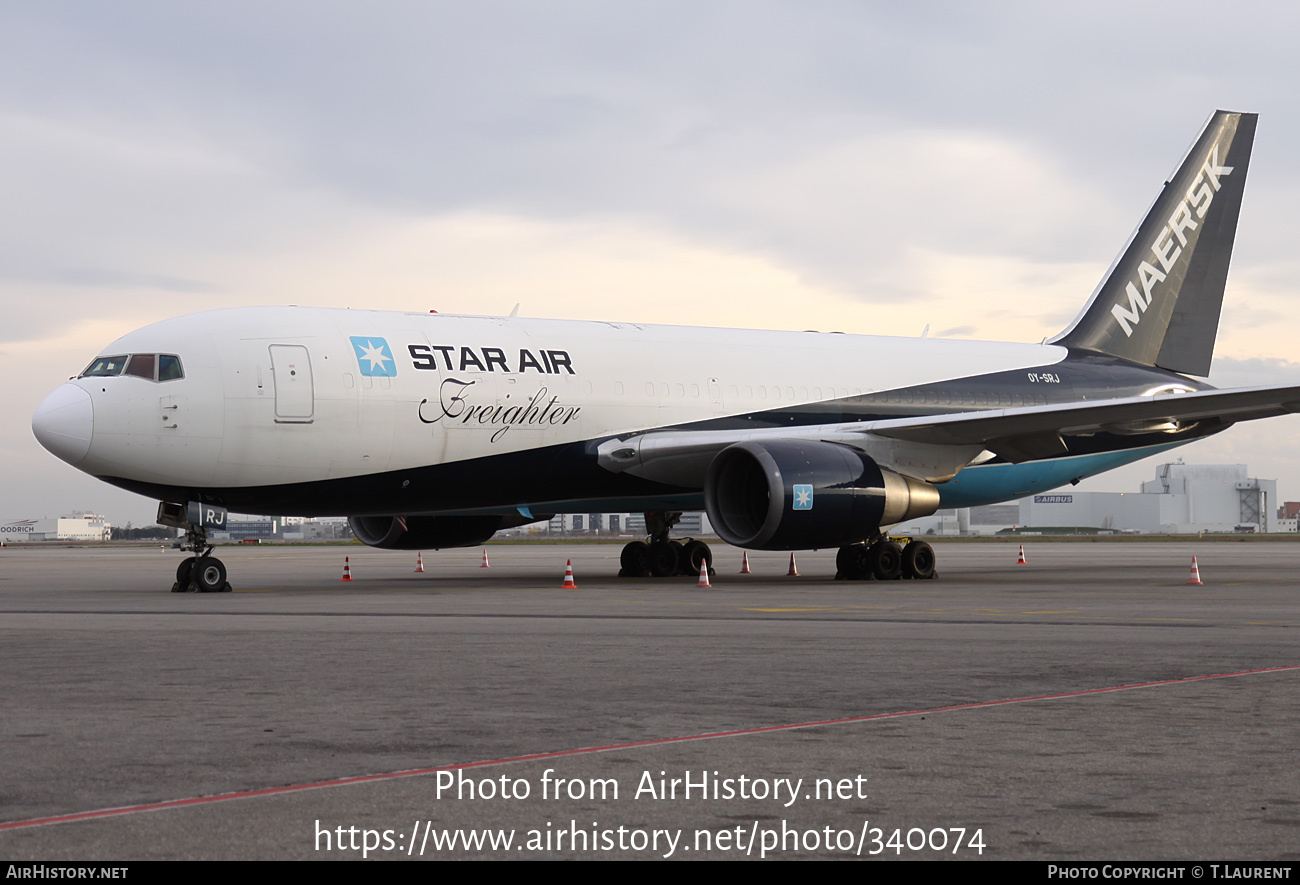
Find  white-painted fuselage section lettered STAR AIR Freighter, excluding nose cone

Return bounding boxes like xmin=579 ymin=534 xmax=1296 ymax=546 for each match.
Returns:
xmin=50 ymin=307 xmax=1066 ymax=493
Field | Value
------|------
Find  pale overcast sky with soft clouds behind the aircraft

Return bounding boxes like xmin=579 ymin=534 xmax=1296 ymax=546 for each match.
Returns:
xmin=0 ymin=0 xmax=1300 ymax=524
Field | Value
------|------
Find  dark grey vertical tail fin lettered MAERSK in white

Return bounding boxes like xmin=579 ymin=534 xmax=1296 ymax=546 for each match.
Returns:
xmin=1052 ymin=110 xmax=1258 ymax=376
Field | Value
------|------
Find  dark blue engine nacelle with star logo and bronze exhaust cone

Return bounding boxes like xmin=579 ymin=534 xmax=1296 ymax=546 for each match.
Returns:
xmin=705 ymin=439 xmax=939 ymax=550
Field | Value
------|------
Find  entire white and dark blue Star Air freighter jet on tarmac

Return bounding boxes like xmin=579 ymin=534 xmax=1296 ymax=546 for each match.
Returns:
xmin=33 ymin=110 xmax=1300 ymax=591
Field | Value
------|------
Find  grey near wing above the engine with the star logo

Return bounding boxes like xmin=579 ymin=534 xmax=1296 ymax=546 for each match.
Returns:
xmin=597 ymin=387 xmax=1300 ymax=486
